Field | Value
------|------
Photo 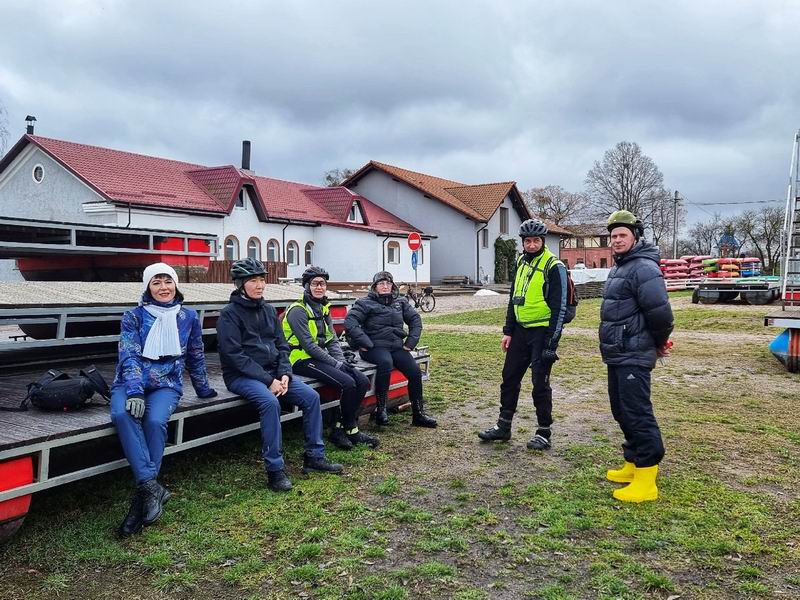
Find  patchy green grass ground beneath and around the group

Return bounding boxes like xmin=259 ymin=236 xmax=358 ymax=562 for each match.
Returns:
xmin=0 ymin=297 xmax=800 ymax=600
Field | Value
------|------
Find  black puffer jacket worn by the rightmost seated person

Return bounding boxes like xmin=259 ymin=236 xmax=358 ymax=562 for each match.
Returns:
xmin=344 ymin=286 xmax=422 ymax=350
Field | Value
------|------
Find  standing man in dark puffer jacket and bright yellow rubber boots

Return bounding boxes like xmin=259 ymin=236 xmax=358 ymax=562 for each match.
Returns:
xmin=600 ymin=210 xmax=673 ymax=502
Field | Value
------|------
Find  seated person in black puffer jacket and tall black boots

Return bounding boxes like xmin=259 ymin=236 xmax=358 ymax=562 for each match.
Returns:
xmin=344 ymin=271 xmax=436 ymax=427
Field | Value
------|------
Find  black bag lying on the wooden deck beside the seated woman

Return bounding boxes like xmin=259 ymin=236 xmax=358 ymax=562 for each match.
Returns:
xmin=0 ymin=365 xmax=111 ymax=412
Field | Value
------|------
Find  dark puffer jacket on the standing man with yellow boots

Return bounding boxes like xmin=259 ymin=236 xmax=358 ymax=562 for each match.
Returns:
xmin=600 ymin=241 xmax=672 ymax=369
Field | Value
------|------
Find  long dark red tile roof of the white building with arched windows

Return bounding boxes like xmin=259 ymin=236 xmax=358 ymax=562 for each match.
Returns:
xmin=0 ymin=135 xmax=419 ymax=234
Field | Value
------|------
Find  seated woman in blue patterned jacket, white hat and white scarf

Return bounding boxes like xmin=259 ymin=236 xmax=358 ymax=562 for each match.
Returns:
xmin=111 ymin=263 xmax=217 ymax=536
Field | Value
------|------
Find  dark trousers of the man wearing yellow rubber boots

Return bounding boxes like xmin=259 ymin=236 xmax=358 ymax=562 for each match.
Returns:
xmin=608 ymin=366 xmax=664 ymax=468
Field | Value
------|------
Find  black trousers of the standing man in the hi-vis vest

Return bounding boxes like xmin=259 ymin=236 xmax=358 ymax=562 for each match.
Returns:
xmin=500 ymin=327 xmax=553 ymax=427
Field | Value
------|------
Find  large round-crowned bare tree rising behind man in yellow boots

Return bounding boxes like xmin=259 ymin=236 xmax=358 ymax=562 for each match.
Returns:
xmin=585 ymin=142 xmax=665 ymax=223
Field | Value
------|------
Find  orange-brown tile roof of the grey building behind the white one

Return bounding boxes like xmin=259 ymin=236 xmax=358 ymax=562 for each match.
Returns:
xmin=342 ymin=160 xmax=569 ymax=235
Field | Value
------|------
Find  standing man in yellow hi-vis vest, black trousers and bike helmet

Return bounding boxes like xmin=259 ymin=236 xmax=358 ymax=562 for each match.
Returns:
xmin=478 ymin=219 xmax=567 ymax=450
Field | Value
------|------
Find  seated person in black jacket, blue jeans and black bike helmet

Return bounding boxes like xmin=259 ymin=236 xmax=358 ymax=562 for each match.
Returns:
xmin=217 ymin=257 xmax=342 ymax=492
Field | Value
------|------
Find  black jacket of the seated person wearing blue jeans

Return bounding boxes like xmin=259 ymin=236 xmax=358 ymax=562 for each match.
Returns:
xmin=217 ymin=290 xmax=292 ymax=386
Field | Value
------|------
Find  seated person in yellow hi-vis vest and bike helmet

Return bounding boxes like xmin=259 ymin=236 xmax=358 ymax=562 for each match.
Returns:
xmin=283 ymin=267 xmax=378 ymax=450
